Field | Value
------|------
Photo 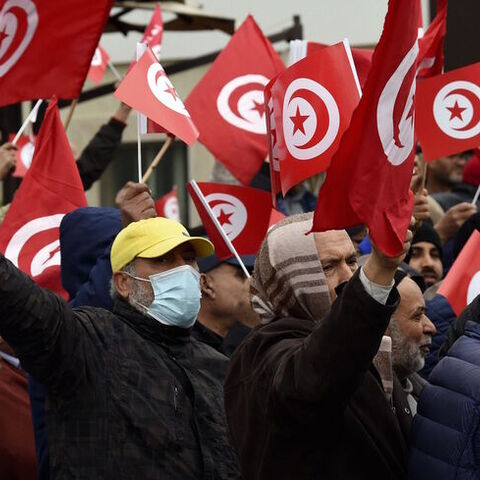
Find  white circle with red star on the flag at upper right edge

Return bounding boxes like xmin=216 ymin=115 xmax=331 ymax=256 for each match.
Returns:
xmin=433 ymin=80 xmax=480 ymax=140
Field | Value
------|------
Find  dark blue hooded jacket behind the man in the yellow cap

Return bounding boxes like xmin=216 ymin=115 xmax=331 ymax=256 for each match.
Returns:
xmin=28 ymin=207 xmax=122 ymax=480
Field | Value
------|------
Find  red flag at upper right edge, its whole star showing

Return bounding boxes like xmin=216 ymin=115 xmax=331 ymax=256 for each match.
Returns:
xmin=416 ymin=63 xmax=480 ymax=161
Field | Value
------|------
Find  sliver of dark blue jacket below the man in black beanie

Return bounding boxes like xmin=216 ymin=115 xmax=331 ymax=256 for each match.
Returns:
xmin=419 ymin=295 xmax=457 ymax=380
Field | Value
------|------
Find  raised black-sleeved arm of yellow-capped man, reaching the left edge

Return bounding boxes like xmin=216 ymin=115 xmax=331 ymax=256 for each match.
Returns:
xmin=0 ymin=254 xmax=89 ymax=395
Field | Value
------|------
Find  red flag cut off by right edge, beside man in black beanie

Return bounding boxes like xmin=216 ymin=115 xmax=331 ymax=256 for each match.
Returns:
xmin=437 ymin=230 xmax=480 ymax=317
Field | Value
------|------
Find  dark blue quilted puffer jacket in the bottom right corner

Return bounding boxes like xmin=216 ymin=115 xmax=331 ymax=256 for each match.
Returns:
xmin=408 ymin=297 xmax=480 ymax=480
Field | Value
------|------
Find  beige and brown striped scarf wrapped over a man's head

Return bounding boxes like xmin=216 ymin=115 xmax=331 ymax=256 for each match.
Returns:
xmin=250 ymin=213 xmax=330 ymax=324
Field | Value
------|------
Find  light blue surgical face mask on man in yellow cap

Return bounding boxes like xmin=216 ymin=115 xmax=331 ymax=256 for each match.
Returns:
xmin=125 ymin=265 xmax=202 ymax=328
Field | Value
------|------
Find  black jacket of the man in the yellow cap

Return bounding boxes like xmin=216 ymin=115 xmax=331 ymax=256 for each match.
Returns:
xmin=0 ymin=256 xmax=239 ymax=480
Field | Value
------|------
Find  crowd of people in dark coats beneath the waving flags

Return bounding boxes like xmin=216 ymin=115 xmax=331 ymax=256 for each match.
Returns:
xmin=0 ymin=91 xmax=480 ymax=480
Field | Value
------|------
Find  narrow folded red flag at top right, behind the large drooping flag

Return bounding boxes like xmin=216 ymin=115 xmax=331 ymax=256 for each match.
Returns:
xmin=417 ymin=0 xmax=447 ymax=78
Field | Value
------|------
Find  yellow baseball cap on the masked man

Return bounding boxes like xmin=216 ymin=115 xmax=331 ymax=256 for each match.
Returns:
xmin=110 ymin=217 xmax=215 ymax=272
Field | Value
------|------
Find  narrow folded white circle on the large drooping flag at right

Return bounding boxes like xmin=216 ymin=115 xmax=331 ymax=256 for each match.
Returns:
xmin=377 ymin=40 xmax=418 ymax=166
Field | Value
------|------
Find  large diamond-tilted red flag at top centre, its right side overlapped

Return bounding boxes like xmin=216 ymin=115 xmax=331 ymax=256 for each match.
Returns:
xmin=185 ymin=16 xmax=285 ymax=185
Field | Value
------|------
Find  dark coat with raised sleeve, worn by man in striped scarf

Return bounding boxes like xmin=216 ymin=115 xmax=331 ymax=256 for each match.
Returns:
xmin=225 ymin=274 xmax=411 ymax=480
